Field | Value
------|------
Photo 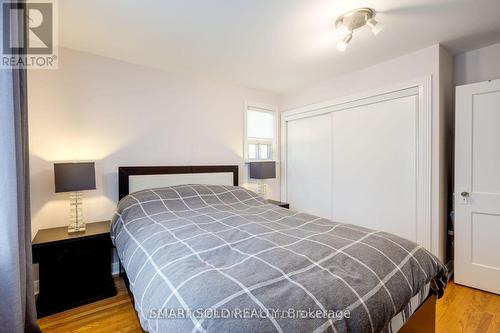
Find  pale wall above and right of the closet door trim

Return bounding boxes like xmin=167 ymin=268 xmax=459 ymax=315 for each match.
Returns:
xmin=280 ymin=45 xmax=453 ymax=260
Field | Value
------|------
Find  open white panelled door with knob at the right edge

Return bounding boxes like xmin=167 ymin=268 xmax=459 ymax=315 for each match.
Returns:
xmin=455 ymin=80 xmax=500 ymax=294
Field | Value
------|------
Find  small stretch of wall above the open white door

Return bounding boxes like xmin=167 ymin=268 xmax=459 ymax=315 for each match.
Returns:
xmin=455 ymin=43 xmax=500 ymax=86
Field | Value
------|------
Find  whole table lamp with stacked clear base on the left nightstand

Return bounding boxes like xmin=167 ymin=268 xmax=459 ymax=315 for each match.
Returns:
xmin=54 ymin=162 xmax=96 ymax=233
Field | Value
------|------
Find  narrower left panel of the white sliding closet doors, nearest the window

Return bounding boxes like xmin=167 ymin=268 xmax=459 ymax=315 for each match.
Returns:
xmin=286 ymin=114 xmax=332 ymax=218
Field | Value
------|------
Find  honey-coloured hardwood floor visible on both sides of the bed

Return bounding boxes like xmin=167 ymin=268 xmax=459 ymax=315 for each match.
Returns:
xmin=38 ymin=279 xmax=500 ymax=333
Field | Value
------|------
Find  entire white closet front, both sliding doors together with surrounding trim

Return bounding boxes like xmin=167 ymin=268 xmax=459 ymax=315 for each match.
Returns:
xmin=282 ymin=81 xmax=432 ymax=246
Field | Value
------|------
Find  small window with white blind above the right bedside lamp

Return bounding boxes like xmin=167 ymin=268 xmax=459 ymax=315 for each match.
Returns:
xmin=245 ymin=104 xmax=277 ymax=160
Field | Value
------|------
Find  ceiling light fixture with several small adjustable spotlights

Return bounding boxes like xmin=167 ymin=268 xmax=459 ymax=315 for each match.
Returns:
xmin=335 ymin=8 xmax=383 ymax=51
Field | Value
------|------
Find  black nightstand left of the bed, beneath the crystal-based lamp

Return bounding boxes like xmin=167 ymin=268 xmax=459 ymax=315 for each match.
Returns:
xmin=32 ymin=221 xmax=116 ymax=317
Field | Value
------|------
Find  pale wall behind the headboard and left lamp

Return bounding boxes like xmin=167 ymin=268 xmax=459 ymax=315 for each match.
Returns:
xmin=28 ymin=49 xmax=279 ymax=236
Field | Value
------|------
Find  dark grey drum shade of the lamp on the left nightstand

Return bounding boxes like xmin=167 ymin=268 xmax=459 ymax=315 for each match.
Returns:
xmin=54 ymin=162 xmax=96 ymax=193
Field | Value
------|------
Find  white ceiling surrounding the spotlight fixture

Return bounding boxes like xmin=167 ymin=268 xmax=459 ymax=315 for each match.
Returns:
xmin=59 ymin=0 xmax=500 ymax=93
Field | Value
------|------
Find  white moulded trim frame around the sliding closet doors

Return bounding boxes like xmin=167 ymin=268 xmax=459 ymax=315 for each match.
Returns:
xmin=280 ymin=75 xmax=438 ymax=252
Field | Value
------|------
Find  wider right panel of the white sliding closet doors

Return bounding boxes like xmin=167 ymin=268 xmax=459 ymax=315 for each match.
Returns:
xmin=331 ymin=96 xmax=418 ymax=241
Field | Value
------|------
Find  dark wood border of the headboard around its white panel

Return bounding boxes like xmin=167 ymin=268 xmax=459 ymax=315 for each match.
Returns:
xmin=118 ymin=165 xmax=238 ymax=200
